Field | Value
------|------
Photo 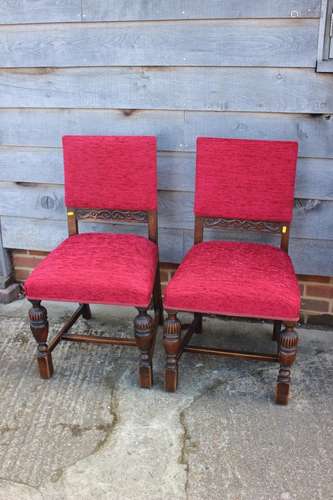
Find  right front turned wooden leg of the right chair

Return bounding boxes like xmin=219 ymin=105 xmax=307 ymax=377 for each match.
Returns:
xmin=276 ymin=323 xmax=298 ymax=405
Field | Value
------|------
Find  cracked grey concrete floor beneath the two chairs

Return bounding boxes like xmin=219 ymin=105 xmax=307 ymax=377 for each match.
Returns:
xmin=0 ymin=300 xmax=333 ymax=500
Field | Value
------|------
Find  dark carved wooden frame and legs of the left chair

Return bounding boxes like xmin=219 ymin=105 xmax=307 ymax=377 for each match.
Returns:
xmin=29 ymin=208 xmax=163 ymax=388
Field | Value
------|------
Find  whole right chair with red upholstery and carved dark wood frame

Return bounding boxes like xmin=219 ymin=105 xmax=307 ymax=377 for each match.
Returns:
xmin=164 ymin=138 xmax=300 ymax=404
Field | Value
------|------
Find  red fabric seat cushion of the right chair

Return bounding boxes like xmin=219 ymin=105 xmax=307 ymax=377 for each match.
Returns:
xmin=164 ymin=241 xmax=300 ymax=321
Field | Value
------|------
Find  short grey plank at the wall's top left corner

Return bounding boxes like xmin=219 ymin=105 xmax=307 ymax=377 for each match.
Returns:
xmin=0 ymin=0 xmax=81 ymax=24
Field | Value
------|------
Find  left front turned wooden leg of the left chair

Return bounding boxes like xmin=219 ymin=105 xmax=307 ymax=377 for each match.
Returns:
xmin=29 ymin=300 xmax=53 ymax=378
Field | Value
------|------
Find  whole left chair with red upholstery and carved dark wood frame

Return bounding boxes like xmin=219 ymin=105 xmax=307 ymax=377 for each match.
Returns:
xmin=25 ymin=136 xmax=163 ymax=387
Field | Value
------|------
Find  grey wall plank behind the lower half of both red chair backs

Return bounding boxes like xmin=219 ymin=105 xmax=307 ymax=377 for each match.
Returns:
xmin=0 ymin=184 xmax=333 ymax=240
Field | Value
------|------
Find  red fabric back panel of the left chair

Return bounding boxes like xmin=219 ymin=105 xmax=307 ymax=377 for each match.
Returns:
xmin=63 ymin=136 xmax=157 ymax=210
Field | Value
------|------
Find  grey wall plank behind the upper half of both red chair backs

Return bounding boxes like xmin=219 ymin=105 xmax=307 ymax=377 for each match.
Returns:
xmin=0 ymin=146 xmax=333 ymax=200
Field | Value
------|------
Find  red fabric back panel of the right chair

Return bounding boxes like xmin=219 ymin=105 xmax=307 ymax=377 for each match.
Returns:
xmin=195 ymin=137 xmax=298 ymax=222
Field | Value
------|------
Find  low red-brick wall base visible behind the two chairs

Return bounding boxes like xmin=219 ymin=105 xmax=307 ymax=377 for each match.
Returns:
xmin=12 ymin=250 xmax=333 ymax=324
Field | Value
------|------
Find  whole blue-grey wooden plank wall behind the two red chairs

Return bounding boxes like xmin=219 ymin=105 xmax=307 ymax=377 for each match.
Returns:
xmin=0 ymin=0 xmax=333 ymax=276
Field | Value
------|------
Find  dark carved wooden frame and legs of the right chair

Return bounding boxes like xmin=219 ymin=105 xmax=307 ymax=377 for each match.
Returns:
xmin=163 ymin=216 xmax=298 ymax=405
